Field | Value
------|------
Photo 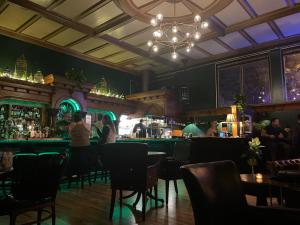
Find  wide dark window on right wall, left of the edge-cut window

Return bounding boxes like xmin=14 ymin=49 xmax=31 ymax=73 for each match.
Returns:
xmin=218 ymin=59 xmax=271 ymax=107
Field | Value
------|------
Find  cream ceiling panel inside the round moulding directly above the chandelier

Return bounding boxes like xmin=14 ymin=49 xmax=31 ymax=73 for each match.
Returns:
xmin=149 ymin=2 xmax=192 ymax=17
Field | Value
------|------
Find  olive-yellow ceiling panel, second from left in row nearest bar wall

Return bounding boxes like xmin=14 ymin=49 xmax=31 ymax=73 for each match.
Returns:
xmin=22 ymin=17 xmax=62 ymax=38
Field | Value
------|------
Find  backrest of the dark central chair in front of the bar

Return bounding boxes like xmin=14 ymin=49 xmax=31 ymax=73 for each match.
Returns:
xmin=103 ymin=143 xmax=148 ymax=190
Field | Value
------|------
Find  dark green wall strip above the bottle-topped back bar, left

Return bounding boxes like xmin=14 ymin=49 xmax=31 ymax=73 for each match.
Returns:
xmin=0 ymin=35 xmax=141 ymax=94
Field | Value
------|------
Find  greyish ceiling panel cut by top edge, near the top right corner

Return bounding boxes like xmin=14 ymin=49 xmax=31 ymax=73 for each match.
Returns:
xmin=248 ymin=0 xmax=287 ymax=15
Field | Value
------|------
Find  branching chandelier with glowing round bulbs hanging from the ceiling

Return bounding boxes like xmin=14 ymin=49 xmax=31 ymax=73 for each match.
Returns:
xmin=147 ymin=0 xmax=208 ymax=60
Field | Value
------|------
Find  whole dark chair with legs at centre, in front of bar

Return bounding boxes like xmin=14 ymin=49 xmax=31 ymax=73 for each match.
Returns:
xmin=103 ymin=143 xmax=158 ymax=220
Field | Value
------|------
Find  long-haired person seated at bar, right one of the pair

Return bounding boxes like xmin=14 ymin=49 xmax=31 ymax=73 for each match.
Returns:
xmin=98 ymin=115 xmax=117 ymax=144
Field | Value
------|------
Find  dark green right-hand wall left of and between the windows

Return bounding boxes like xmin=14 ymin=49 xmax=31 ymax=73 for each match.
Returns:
xmin=151 ymin=49 xmax=285 ymax=110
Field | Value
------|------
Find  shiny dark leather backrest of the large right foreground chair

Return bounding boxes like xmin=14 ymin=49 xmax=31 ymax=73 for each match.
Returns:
xmin=181 ymin=161 xmax=247 ymax=225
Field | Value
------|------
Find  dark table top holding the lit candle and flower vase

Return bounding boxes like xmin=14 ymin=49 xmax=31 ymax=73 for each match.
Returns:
xmin=240 ymin=174 xmax=300 ymax=191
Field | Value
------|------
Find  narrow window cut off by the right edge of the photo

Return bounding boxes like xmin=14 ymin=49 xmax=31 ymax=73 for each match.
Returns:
xmin=283 ymin=53 xmax=300 ymax=101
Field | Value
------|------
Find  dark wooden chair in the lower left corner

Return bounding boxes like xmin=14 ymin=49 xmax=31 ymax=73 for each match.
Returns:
xmin=0 ymin=154 xmax=65 ymax=225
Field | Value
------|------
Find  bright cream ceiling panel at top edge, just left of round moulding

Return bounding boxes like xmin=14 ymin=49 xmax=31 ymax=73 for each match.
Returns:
xmin=80 ymin=1 xmax=122 ymax=27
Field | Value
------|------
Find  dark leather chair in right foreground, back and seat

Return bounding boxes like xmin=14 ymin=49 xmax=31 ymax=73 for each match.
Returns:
xmin=182 ymin=161 xmax=300 ymax=225
